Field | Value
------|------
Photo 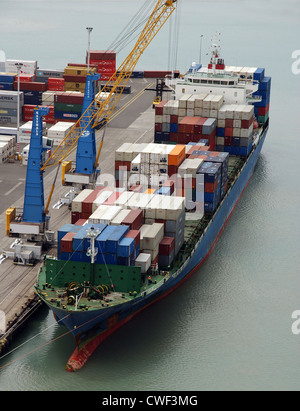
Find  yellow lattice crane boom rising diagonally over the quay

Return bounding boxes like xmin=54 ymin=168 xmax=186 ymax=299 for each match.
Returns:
xmin=42 ymin=0 xmax=177 ymax=170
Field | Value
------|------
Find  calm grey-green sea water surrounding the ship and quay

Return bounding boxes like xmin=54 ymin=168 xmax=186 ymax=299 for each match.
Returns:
xmin=0 ymin=0 xmax=300 ymax=391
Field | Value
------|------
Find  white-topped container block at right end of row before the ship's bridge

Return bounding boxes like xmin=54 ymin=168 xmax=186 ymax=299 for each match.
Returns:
xmin=216 ymin=104 xmax=254 ymax=156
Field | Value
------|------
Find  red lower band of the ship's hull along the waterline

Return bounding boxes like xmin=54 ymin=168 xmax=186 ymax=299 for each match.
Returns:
xmin=66 ymin=169 xmax=253 ymax=372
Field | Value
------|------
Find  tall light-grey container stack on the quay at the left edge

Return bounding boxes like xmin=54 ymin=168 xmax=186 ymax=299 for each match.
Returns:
xmin=0 ymin=90 xmax=24 ymax=124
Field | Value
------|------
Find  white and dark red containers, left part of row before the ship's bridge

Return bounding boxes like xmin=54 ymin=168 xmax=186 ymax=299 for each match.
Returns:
xmin=154 ymin=94 xmax=223 ymax=148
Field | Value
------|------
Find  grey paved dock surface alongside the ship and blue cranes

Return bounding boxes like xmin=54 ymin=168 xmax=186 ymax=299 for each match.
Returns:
xmin=0 ymin=79 xmax=161 ymax=346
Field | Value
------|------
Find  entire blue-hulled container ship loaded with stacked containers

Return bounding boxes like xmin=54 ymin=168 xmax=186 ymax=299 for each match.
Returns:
xmin=29 ymin=37 xmax=271 ymax=371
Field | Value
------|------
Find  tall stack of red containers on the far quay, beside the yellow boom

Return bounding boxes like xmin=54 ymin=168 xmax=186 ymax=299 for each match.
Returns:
xmin=86 ymin=50 xmax=117 ymax=82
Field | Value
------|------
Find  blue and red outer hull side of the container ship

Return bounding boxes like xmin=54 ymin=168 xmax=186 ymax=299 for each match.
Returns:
xmin=46 ymin=124 xmax=268 ymax=371
